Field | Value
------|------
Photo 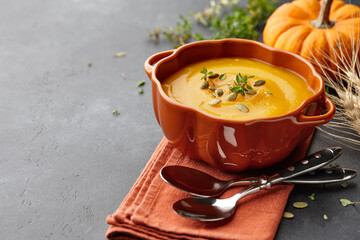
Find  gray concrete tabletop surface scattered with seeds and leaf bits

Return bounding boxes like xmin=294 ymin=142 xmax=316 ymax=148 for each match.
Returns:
xmin=0 ymin=0 xmax=360 ymax=240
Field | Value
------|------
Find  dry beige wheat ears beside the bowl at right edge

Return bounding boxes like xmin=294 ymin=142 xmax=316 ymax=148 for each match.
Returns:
xmin=312 ymin=16 xmax=360 ymax=151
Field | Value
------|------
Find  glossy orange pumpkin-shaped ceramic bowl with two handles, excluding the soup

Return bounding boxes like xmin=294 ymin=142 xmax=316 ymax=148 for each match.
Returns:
xmin=145 ymin=39 xmax=335 ymax=171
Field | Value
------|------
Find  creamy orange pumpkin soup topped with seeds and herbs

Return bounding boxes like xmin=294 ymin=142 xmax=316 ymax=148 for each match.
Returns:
xmin=162 ymin=58 xmax=314 ymax=120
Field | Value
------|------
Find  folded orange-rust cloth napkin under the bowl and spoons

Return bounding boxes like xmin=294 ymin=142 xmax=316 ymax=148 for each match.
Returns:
xmin=106 ymin=137 xmax=311 ymax=240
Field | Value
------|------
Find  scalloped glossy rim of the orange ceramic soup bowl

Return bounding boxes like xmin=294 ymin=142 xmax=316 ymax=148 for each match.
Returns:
xmin=146 ymin=38 xmax=325 ymax=124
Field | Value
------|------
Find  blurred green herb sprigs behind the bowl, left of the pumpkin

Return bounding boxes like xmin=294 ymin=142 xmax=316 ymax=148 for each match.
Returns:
xmin=149 ymin=0 xmax=278 ymax=47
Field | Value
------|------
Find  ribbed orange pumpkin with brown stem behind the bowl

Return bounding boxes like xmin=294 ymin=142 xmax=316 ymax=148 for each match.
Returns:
xmin=263 ymin=0 xmax=360 ymax=69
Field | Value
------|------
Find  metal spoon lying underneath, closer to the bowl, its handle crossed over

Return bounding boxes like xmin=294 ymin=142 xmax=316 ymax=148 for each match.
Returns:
xmin=160 ymin=166 xmax=357 ymax=197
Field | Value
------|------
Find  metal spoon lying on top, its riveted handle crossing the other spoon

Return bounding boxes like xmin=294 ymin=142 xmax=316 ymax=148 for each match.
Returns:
xmin=173 ymin=147 xmax=342 ymax=221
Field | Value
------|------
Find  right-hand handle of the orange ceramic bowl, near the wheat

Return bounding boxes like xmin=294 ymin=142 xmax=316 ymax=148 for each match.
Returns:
xmin=297 ymin=96 xmax=336 ymax=126
